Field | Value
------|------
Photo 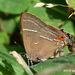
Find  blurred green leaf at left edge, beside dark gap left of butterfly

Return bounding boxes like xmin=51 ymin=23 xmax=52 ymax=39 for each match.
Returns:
xmin=0 ymin=16 xmax=16 ymax=34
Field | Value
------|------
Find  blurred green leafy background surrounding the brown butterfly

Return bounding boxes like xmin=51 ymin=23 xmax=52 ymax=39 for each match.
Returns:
xmin=0 ymin=0 xmax=75 ymax=75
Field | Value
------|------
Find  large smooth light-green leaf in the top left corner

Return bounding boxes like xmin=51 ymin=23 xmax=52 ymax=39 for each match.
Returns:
xmin=0 ymin=0 xmax=30 ymax=14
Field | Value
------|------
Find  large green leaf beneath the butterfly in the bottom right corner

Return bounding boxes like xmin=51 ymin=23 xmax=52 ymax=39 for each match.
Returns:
xmin=31 ymin=55 xmax=75 ymax=75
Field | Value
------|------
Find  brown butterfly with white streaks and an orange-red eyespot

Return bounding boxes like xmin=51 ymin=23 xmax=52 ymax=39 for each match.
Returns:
xmin=21 ymin=13 xmax=70 ymax=61
